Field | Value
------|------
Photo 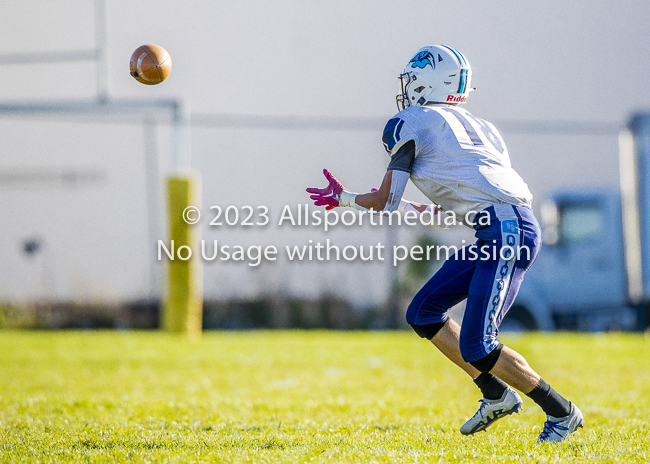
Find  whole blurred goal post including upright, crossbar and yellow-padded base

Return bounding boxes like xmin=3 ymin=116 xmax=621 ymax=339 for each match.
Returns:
xmin=0 ymin=0 xmax=203 ymax=337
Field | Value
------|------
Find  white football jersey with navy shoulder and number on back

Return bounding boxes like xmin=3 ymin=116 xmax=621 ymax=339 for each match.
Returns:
xmin=383 ymin=104 xmax=533 ymax=216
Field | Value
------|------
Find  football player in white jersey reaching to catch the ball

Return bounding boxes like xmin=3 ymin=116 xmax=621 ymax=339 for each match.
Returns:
xmin=307 ymin=45 xmax=583 ymax=442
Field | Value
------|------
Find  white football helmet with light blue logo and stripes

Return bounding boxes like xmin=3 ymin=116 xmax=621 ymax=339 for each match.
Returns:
xmin=396 ymin=45 xmax=474 ymax=111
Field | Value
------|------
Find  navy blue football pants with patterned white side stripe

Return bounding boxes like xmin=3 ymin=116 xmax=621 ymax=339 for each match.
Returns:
xmin=406 ymin=205 xmax=541 ymax=362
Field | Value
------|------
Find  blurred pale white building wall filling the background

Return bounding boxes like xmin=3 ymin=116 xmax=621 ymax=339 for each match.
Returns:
xmin=0 ymin=0 xmax=650 ymax=304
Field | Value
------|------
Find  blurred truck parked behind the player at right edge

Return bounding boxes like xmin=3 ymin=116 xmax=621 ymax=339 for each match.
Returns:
xmin=502 ymin=113 xmax=650 ymax=331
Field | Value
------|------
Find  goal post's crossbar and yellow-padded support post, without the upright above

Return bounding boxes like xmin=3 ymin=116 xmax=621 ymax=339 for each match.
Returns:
xmin=0 ymin=99 xmax=203 ymax=338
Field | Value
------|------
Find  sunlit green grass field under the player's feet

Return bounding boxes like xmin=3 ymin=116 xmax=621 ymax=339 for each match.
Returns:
xmin=0 ymin=331 xmax=650 ymax=463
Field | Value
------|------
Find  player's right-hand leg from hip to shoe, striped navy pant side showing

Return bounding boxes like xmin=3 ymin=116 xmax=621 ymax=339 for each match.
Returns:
xmin=460 ymin=208 xmax=582 ymax=441
